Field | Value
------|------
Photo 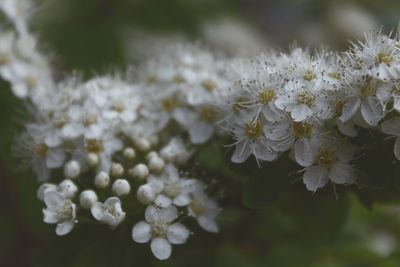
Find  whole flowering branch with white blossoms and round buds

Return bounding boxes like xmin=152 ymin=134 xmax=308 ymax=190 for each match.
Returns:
xmin=0 ymin=0 xmax=400 ymax=260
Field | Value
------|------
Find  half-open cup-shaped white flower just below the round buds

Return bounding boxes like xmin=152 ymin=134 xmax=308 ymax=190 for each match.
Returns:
xmin=90 ymin=197 xmax=126 ymax=229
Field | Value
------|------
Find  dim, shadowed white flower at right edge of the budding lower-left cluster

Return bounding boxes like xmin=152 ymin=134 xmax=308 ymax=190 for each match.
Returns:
xmin=188 ymin=188 xmax=221 ymax=233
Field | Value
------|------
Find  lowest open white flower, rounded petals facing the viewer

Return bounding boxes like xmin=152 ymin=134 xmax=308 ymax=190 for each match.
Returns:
xmin=132 ymin=206 xmax=189 ymax=260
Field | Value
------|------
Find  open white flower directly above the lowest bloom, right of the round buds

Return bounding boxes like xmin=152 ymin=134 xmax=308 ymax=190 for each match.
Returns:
xmin=147 ymin=164 xmax=196 ymax=208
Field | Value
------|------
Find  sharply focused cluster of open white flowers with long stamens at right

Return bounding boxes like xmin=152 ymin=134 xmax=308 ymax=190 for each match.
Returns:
xmin=224 ymin=31 xmax=400 ymax=191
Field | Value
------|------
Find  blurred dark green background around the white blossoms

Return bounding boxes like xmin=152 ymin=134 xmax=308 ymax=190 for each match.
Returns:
xmin=0 ymin=0 xmax=400 ymax=267
